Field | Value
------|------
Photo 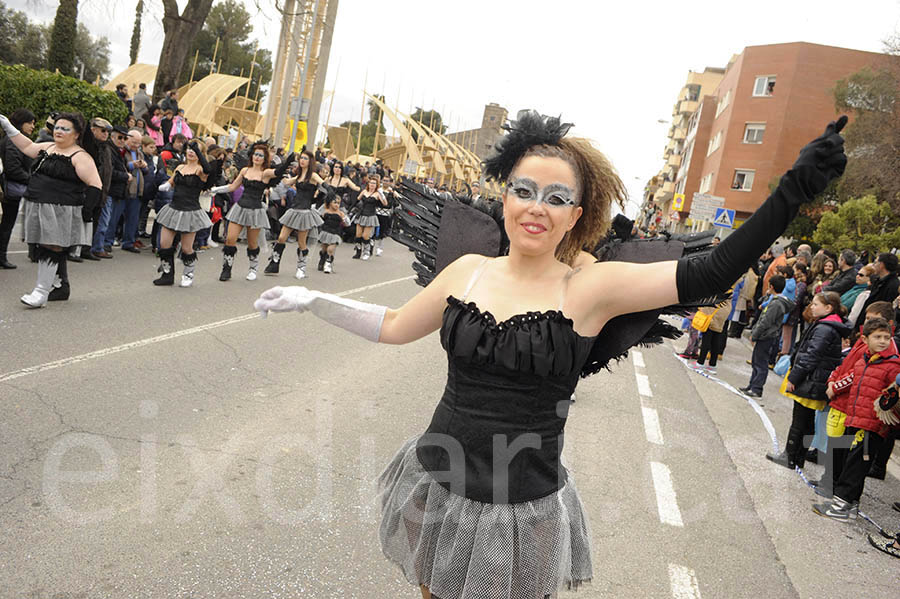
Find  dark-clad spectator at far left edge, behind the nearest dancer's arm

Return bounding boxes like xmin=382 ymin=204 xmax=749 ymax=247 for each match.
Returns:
xmin=0 ymin=108 xmax=36 ymax=269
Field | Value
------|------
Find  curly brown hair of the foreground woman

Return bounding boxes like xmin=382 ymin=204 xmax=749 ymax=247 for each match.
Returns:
xmin=513 ymin=137 xmax=628 ymax=266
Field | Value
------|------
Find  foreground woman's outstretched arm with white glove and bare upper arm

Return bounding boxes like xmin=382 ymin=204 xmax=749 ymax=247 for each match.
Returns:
xmin=253 ymin=254 xmax=483 ymax=345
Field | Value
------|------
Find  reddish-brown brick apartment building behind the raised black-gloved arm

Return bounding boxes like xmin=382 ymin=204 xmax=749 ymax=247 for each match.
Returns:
xmin=645 ymin=42 xmax=884 ymax=230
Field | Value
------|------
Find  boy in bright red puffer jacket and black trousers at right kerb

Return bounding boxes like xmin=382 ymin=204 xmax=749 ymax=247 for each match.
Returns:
xmin=813 ymin=318 xmax=900 ymax=522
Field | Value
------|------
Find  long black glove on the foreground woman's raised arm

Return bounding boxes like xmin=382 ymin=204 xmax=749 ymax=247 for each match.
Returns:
xmin=675 ymin=116 xmax=847 ymax=302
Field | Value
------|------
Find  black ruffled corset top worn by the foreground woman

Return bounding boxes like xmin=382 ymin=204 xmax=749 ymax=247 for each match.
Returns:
xmin=416 ymin=296 xmax=596 ymax=503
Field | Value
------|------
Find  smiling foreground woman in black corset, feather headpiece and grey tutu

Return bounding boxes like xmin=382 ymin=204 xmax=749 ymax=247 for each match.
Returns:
xmin=255 ymin=111 xmax=846 ymax=599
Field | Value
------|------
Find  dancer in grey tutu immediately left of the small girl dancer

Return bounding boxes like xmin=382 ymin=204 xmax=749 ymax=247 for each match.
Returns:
xmin=265 ymin=150 xmax=327 ymax=279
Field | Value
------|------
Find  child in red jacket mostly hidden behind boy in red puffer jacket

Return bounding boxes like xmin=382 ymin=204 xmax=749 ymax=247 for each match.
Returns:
xmin=815 ymin=302 xmax=896 ymax=498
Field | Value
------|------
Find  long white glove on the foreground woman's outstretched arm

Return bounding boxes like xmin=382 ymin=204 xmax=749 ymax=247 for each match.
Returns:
xmin=253 ymin=287 xmax=387 ymax=343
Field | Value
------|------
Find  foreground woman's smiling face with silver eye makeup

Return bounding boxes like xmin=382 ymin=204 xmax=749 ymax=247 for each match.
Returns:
xmin=503 ymin=156 xmax=582 ymax=255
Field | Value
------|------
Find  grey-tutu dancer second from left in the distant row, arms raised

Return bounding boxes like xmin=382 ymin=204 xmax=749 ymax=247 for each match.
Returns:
xmin=209 ymin=142 xmax=294 ymax=281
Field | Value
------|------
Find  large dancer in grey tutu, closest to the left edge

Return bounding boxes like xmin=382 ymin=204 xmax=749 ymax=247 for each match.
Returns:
xmin=0 ymin=112 xmax=101 ymax=308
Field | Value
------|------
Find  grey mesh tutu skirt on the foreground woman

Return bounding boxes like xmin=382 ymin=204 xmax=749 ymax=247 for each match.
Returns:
xmin=378 ymin=438 xmax=592 ymax=599
